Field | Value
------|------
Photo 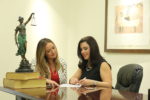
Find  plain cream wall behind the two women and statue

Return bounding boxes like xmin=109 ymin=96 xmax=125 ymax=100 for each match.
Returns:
xmin=0 ymin=0 xmax=150 ymax=100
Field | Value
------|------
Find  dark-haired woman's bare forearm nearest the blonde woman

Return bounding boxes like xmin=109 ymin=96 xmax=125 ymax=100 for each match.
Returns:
xmin=69 ymin=68 xmax=82 ymax=84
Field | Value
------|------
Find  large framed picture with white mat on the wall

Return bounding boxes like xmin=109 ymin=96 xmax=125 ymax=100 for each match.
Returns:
xmin=104 ymin=0 xmax=150 ymax=53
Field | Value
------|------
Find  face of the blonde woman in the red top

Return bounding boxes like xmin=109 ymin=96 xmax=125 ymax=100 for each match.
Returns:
xmin=45 ymin=42 xmax=57 ymax=60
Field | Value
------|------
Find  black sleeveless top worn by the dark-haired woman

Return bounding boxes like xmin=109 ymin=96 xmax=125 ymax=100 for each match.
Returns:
xmin=80 ymin=62 xmax=102 ymax=81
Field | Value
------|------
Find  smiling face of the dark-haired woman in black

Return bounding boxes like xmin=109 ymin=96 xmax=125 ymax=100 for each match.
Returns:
xmin=80 ymin=42 xmax=90 ymax=60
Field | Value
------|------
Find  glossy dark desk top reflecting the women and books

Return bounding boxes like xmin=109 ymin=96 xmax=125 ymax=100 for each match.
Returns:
xmin=0 ymin=87 xmax=148 ymax=100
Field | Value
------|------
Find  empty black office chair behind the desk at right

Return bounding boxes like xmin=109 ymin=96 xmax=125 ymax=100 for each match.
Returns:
xmin=115 ymin=64 xmax=143 ymax=92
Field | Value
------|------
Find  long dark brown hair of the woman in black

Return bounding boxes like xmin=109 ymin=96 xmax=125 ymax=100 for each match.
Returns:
xmin=77 ymin=36 xmax=105 ymax=69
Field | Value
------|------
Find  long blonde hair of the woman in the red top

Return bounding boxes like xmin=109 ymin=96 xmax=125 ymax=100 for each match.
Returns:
xmin=36 ymin=38 xmax=60 ymax=78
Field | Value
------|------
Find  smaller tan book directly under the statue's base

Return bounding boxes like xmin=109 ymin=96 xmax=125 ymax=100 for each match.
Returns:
xmin=6 ymin=72 xmax=40 ymax=80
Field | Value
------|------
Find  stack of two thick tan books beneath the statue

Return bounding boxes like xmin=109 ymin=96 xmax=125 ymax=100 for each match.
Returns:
xmin=3 ymin=72 xmax=46 ymax=89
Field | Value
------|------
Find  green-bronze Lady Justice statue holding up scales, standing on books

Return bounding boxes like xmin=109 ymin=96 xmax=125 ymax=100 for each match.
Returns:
xmin=15 ymin=13 xmax=36 ymax=72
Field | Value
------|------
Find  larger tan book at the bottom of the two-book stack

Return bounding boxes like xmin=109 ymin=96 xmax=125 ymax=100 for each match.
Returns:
xmin=3 ymin=78 xmax=46 ymax=89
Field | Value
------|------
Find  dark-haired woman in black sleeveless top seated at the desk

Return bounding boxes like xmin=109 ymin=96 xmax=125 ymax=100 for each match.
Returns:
xmin=69 ymin=36 xmax=112 ymax=87
